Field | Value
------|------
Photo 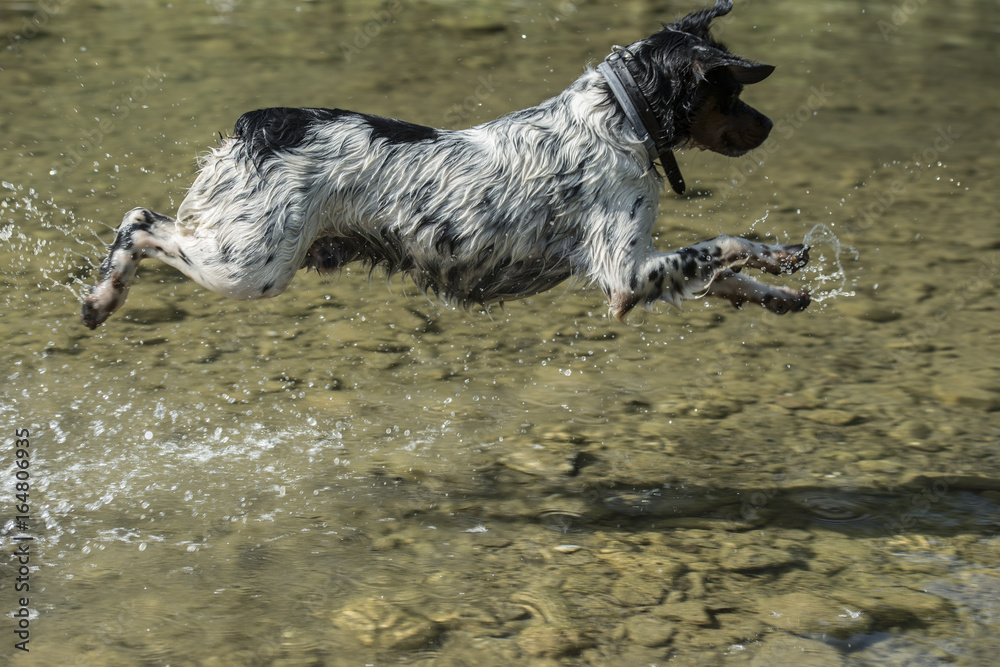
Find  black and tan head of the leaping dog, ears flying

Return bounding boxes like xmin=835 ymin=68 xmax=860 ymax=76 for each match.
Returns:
xmin=627 ymin=0 xmax=774 ymax=157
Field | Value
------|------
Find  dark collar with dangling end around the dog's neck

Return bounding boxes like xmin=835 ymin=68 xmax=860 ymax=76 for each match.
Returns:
xmin=597 ymin=47 xmax=685 ymax=195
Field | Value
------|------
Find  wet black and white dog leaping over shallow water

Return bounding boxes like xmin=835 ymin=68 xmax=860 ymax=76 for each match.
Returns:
xmin=83 ymin=0 xmax=809 ymax=329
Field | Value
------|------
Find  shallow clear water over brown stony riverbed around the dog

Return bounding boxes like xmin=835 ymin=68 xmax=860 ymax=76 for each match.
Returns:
xmin=0 ymin=0 xmax=1000 ymax=665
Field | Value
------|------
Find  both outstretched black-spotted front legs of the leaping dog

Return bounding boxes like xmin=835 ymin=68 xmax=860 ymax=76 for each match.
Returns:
xmin=609 ymin=236 xmax=809 ymax=319
